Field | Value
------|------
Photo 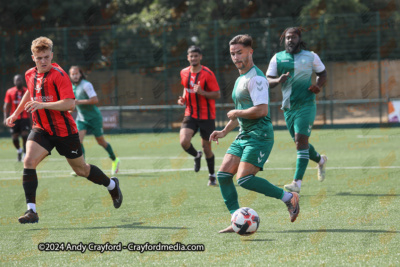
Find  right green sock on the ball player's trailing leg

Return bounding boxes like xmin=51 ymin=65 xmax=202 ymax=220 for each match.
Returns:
xmin=238 ymin=174 xmax=284 ymax=199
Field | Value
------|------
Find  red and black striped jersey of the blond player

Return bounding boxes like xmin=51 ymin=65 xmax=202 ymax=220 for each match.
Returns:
xmin=25 ymin=63 xmax=78 ymax=137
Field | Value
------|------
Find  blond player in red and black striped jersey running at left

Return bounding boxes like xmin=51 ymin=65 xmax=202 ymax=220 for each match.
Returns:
xmin=6 ymin=37 xmax=123 ymax=223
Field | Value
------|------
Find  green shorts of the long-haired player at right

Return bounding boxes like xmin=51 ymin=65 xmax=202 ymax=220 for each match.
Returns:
xmin=284 ymin=105 xmax=317 ymax=138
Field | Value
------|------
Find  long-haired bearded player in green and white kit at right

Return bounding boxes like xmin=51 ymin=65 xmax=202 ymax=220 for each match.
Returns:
xmin=267 ymin=27 xmax=328 ymax=193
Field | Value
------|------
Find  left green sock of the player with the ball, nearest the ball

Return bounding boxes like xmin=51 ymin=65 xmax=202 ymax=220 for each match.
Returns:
xmin=217 ymin=172 xmax=239 ymax=214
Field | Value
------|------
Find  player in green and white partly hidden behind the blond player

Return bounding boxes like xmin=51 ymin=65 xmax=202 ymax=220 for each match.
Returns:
xmin=69 ymin=66 xmax=120 ymax=175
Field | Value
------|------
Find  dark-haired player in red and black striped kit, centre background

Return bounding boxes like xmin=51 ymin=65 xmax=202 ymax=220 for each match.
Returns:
xmin=178 ymin=46 xmax=221 ymax=186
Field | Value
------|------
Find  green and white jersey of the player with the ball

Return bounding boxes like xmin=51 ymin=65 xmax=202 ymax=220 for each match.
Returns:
xmin=232 ymin=66 xmax=274 ymax=140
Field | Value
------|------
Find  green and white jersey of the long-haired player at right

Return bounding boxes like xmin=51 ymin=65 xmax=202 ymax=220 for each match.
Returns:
xmin=267 ymin=50 xmax=325 ymax=109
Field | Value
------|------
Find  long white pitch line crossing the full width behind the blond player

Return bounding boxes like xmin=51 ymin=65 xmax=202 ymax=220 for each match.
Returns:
xmin=0 ymin=166 xmax=400 ymax=181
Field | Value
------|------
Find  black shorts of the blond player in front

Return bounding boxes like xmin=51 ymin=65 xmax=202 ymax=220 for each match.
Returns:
xmin=28 ymin=128 xmax=82 ymax=159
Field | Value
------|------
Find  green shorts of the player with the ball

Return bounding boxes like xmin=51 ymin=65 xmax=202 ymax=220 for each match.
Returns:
xmin=226 ymin=138 xmax=274 ymax=171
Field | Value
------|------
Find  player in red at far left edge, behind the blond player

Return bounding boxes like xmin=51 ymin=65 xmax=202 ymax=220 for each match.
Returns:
xmin=3 ymin=74 xmax=31 ymax=161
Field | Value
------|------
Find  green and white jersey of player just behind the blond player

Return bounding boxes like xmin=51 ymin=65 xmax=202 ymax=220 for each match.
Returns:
xmin=72 ymin=80 xmax=101 ymax=121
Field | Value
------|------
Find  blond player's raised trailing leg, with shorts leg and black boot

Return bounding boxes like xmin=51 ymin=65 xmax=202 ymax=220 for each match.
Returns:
xmin=56 ymin=134 xmax=123 ymax=208
